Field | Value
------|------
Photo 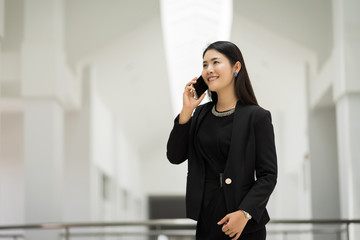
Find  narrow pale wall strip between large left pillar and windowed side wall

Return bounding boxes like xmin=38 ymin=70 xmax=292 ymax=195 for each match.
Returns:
xmin=64 ymin=66 xmax=93 ymax=221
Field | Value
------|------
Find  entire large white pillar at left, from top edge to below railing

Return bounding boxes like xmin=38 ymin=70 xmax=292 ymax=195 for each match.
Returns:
xmin=21 ymin=0 xmax=68 ymax=237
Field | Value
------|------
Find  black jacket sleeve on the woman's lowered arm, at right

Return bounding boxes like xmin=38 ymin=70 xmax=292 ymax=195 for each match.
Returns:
xmin=239 ymin=109 xmax=277 ymax=222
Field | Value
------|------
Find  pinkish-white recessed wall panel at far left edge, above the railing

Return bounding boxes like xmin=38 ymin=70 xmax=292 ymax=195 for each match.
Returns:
xmin=0 ymin=111 xmax=24 ymax=225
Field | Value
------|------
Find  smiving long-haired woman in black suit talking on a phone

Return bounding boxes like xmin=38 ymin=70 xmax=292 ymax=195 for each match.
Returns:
xmin=167 ymin=41 xmax=277 ymax=240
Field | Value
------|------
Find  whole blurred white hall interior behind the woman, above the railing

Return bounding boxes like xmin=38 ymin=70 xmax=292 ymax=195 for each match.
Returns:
xmin=0 ymin=0 xmax=360 ymax=240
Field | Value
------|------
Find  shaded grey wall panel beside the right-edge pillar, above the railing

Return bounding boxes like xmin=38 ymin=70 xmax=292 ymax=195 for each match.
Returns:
xmin=309 ymin=107 xmax=340 ymax=218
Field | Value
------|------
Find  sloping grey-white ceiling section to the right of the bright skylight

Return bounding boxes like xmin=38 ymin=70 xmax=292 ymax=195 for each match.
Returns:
xmin=233 ymin=0 xmax=333 ymax=67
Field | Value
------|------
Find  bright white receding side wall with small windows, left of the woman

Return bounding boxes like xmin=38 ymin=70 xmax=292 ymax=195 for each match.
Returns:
xmin=90 ymin=67 xmax=146 ymax=220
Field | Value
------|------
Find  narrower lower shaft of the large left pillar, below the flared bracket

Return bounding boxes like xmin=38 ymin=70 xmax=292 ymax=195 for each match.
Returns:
xmin=24 ymin=100 xmax=64 ymax=239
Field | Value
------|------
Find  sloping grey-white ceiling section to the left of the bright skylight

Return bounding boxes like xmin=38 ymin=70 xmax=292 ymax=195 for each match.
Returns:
xmin=64 ymin=0 xmax=160 ymax=64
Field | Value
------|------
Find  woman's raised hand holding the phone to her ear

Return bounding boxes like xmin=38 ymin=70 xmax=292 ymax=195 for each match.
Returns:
xmin=179 ymin=77 xmax=206 ymax=124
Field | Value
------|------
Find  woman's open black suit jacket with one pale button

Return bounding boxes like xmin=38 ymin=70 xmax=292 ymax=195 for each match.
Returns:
xmin=167 ymin=102 xmax=277 ymax=232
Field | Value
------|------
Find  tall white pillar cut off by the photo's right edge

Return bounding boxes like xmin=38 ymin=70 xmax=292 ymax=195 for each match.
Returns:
xmin=333 ymin=0 xmax=360 ymax=239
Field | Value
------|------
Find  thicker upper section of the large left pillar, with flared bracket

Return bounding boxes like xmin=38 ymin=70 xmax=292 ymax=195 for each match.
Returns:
xmin=21 ymin=0 xmax=80 ymax=109
